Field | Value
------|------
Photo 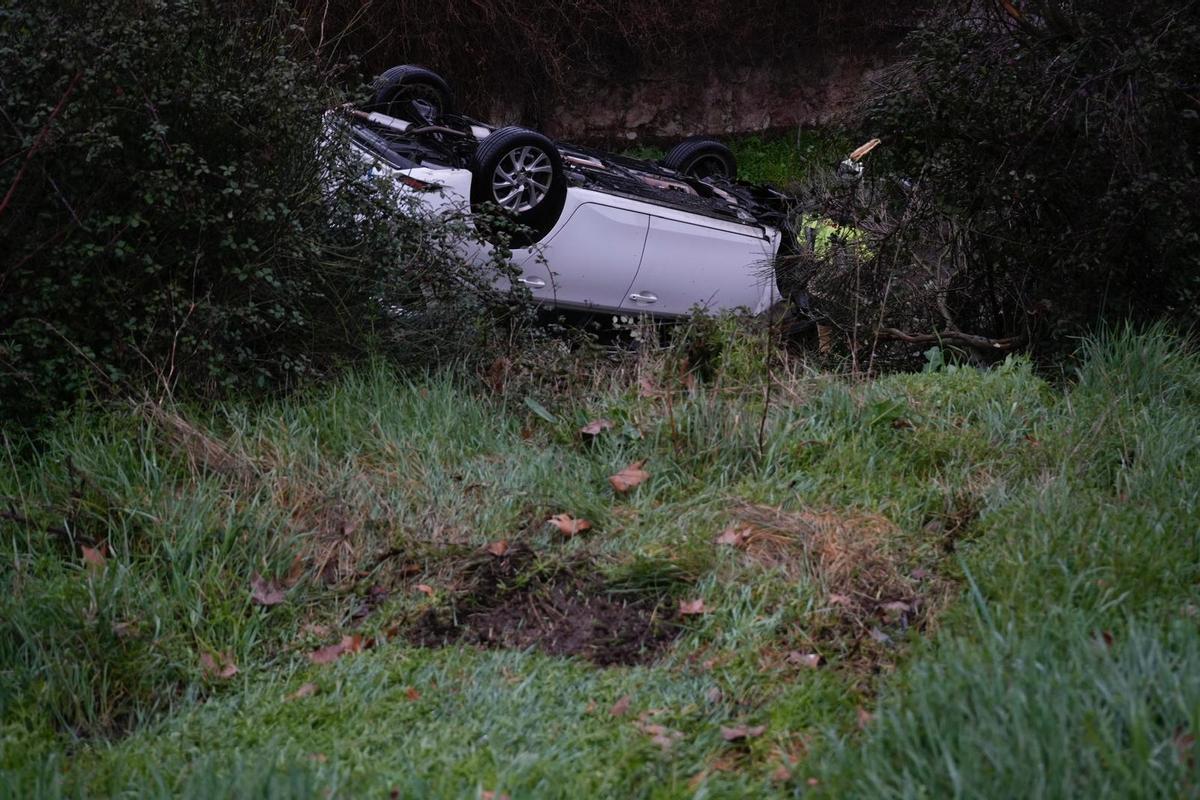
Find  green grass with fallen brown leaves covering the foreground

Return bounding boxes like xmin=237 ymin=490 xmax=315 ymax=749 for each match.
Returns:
xmin=0 ymin=321 xmax=1200 ymax=798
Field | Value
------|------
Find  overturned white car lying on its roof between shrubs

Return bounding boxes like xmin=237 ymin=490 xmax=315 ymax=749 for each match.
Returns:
xmin=343 ymin=65 xmax=873 ymax=317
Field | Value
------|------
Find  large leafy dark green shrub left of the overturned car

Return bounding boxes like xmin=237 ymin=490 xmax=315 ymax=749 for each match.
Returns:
xmin=0 ymin=0 xmax=525 ymax=420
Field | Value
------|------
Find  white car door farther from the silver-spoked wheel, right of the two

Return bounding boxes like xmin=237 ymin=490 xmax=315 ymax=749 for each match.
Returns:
xmin=622 ymin=216 xmax=770 ymax=314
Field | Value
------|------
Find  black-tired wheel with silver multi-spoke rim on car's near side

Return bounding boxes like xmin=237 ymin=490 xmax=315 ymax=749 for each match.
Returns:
xmin=470 ymin=126 xmax=566 ymax=247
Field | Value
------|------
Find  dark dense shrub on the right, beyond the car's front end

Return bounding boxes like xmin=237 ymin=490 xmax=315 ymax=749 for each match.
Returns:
xmin=870 ymin=0 xmax=1200 ymax=342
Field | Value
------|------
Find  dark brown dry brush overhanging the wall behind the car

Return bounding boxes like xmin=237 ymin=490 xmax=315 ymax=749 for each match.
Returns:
xmin=288 ymin=0 xmax=916 ymax=125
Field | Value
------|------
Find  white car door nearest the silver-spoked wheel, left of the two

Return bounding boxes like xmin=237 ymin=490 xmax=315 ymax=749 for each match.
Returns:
xmin=520 ymin=203 xmax=650 ymax=311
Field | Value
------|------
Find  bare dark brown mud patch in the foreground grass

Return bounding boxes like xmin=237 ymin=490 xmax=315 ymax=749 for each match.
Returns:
xmin=406 ymin=552 xmax=682 ymax=667
